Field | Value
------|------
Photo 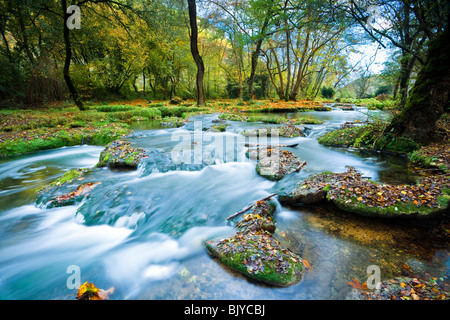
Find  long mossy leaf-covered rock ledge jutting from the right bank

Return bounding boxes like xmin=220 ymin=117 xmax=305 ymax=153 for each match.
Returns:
xmin=278 ymin=168 xmax=450 ymax=218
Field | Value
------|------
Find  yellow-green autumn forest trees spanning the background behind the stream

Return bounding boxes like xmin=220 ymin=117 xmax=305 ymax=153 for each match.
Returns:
xmin=0 ymin=0 xmax=449 ymax=115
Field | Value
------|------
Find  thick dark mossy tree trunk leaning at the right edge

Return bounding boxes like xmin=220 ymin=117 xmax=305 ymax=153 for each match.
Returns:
xmin=386 ymin=27 xmax=450 ymax=143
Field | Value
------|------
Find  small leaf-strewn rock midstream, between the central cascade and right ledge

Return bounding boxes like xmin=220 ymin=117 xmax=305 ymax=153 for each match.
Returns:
xmin=247 ymin=147 xmax=305 ymax=180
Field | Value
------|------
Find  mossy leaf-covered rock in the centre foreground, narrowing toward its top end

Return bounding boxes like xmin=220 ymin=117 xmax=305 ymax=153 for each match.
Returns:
xmin=206 ymin=201 xmax=304 ymax=286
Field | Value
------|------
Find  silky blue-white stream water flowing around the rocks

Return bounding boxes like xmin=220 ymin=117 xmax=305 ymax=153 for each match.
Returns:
xmin=0 ymin=109 xmax=449 ymax=300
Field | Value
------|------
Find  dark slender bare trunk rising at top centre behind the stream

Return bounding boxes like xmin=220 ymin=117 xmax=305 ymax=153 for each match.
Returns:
xmin=188 ymin=0 xmax=205 ymax=106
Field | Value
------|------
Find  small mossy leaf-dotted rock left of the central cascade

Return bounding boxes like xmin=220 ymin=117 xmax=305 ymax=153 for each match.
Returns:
xmin=96 ymin=140 xmax=148 ymax=169
